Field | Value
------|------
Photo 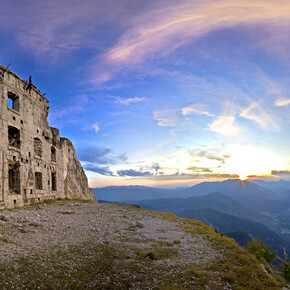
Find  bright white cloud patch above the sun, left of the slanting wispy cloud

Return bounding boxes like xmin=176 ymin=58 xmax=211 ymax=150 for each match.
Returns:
xmin=209 ymin=115 xmax=241 ymax=137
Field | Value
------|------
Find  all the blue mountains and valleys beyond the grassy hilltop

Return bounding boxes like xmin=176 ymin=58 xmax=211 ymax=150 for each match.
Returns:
xmin=94 ymin=179 xmax=290 ymax=254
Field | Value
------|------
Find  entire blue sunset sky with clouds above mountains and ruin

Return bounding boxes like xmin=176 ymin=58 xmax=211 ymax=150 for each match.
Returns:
xmin=0 ymin=0 xmax=290 ymax=187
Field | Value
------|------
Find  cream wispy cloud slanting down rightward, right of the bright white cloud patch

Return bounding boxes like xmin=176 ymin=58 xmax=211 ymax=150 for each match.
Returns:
xmin=240 ymin=102 xmax=279 ymax=131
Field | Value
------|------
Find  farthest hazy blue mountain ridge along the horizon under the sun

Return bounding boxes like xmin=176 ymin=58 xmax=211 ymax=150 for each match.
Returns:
xmin=94 ymin=179 xmax=290 ymax=212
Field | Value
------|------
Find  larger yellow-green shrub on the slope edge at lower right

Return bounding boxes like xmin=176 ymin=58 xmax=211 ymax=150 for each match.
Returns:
xmin=248 ymin=239 xmax=277 ymax=263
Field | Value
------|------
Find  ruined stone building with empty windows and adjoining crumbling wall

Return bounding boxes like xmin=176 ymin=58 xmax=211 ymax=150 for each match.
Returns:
xmin=0 ymin=65 xmax=95 ymax=208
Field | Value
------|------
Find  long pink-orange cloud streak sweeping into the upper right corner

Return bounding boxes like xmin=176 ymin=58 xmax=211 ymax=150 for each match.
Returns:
xmin=105 ymin=0 xmax=290 ymax=65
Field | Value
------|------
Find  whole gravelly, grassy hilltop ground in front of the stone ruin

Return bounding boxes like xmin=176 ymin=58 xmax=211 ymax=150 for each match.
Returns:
xmin=0 ymin=201 xmax=284 ymax=289
